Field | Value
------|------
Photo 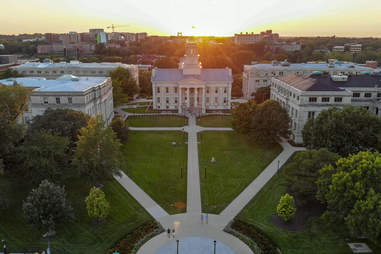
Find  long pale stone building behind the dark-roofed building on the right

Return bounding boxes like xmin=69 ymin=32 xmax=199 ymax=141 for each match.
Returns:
xmin=242 ymin=60 xmax=373 ymax=99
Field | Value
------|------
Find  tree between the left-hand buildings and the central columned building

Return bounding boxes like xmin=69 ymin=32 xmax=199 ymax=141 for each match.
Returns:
xmin=110 ymin=67 xmax=139 ymax=105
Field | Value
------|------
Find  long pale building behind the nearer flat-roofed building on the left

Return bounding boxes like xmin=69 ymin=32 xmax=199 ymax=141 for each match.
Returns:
xmin=12 ymin=61 xmax=139 ymax=84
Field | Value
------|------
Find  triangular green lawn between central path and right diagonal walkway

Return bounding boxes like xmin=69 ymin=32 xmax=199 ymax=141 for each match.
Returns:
xmin=199 ymin=132 xmax=282 ymax=213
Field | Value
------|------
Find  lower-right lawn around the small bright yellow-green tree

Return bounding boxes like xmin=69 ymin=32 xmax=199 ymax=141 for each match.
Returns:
xmin=238 ymin=157 xmax=380 ymax=254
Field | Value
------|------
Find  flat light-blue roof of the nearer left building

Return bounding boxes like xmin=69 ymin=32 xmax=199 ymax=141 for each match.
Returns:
xmin=0 ymin=75 xmax=108 ymax=92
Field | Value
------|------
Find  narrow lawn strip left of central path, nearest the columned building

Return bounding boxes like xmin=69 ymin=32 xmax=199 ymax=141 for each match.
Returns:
xmin=127 ymin=116 xmax=188 ymax=127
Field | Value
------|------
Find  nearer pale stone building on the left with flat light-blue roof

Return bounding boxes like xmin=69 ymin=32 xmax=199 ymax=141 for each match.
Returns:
xmin=0 ymin=75 xmax=114 ymax=125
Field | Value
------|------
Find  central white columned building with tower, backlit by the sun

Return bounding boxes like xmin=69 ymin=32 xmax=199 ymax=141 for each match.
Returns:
xmin=151 ymin=43 xmax=233 ymax=113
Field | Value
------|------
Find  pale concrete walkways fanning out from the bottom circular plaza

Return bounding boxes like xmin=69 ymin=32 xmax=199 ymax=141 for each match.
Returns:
xmin=115 ymin=115 xmax=304 ymax=254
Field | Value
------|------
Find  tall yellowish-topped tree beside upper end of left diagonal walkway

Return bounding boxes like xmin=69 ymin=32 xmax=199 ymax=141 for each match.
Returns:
xmin=73 ymin=115 xmax=122 ymax=183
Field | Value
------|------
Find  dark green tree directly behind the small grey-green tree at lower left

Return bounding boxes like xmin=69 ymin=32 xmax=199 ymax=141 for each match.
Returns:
xmin=16 ymin=132 xmax=71 ymax=183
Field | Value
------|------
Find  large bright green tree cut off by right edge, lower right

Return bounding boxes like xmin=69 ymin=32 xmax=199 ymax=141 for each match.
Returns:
xmin=317 ymin=151 xmax=381 ymax=243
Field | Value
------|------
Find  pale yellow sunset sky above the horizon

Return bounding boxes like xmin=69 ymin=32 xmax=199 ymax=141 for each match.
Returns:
xmin=0 ymin=0 xmax=381 ymax=37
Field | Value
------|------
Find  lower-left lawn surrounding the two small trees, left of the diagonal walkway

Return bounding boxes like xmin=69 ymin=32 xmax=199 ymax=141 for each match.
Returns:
xmin=0 ymin=177 xmax=152 ymax=254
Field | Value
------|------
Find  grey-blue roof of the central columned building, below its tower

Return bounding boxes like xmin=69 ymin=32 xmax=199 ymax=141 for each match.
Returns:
xmin=152 ymin=68 xmax=233 ymax=82
